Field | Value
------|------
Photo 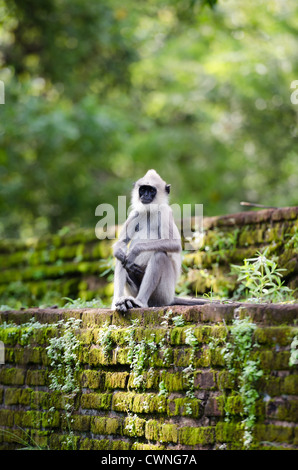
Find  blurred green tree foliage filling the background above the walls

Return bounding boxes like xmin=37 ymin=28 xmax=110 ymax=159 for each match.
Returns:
xmin=0 ymin=0 xmax=298 ymax=236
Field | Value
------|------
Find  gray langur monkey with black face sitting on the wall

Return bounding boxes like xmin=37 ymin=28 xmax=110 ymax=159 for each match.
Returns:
xmin=112 ymin=170 xmax=208 ymax=313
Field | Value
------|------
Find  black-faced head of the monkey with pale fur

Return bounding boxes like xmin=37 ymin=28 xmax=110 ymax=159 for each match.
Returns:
xmin=132 ymin=170 xmax=171 ymax=211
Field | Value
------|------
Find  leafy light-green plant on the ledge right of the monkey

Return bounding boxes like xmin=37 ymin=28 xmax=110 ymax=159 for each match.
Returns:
xmin=231 ymin=249 xmax=292 ymax=302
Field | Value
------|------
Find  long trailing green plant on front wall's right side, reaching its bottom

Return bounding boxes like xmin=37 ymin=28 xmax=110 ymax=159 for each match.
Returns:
xmin=222 ymin=317 xmax=263 ymax=449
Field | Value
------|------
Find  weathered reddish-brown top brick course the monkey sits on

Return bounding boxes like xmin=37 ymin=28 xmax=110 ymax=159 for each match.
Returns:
xmin=0 ymin=301 xmax=298 ymax=327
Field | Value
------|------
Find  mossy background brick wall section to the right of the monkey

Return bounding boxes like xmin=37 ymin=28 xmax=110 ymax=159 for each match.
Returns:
xmin=182 ymin=207 xmax=298 ymax=297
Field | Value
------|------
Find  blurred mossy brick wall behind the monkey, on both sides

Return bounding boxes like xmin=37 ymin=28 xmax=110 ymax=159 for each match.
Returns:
xmin=0 ymin=207 xmax=298 ymax=308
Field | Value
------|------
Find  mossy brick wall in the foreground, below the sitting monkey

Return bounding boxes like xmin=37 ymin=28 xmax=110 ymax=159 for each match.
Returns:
xmin=0 ymin=302 xmax=298 ymax=450
